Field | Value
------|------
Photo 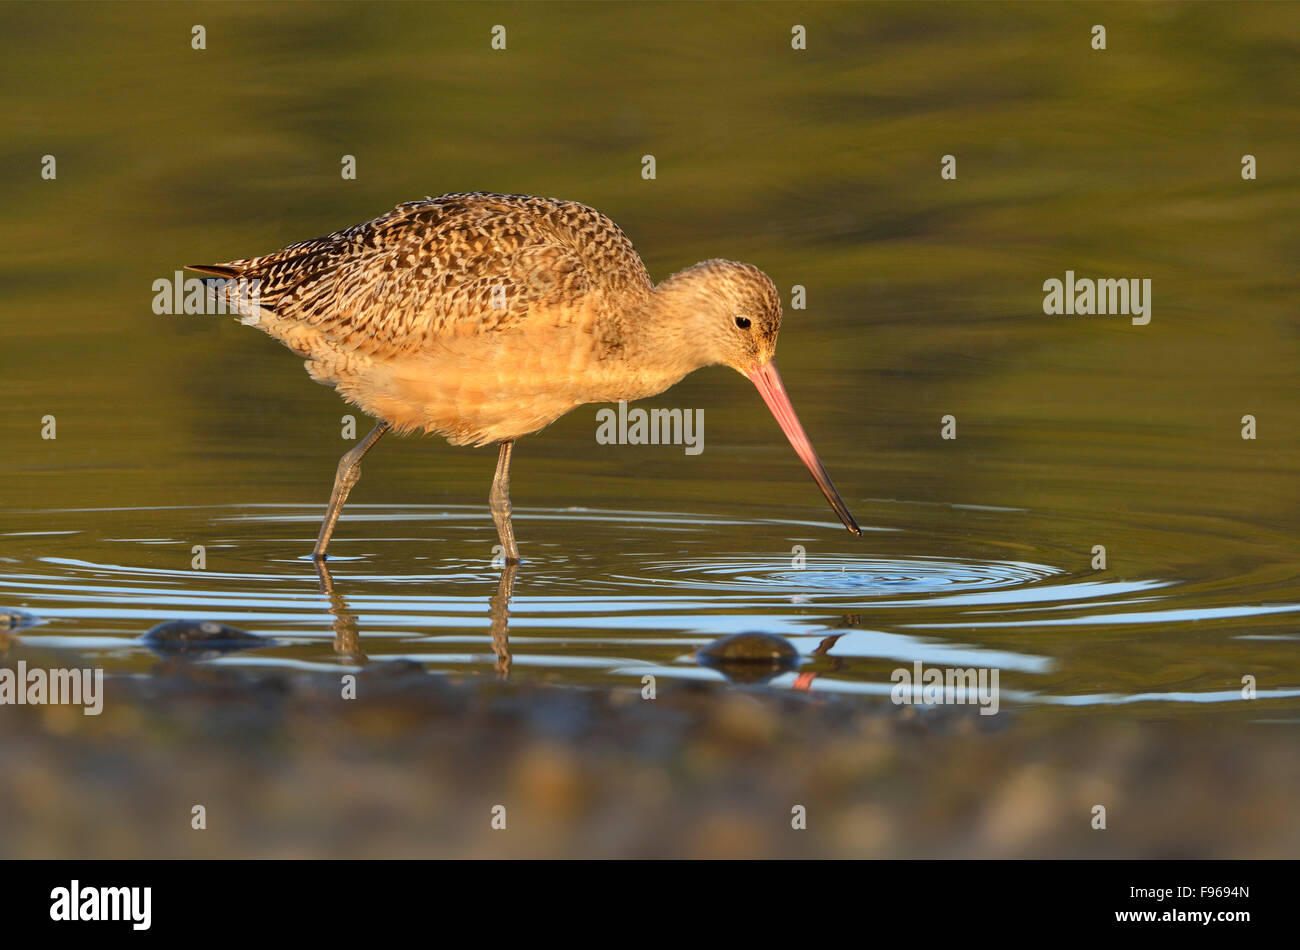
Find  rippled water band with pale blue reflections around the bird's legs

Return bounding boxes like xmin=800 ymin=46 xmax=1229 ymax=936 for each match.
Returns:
xmin=0 ymin=503 xmax=1300 ymax=713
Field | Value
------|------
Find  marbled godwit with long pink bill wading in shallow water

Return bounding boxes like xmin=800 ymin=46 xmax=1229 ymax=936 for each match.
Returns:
xmin=190 ymin=192 xmax=861 ymax=563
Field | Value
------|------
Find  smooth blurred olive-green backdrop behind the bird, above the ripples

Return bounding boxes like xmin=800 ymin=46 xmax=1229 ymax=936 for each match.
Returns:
xmin=0 ymin=3 xmax=1300 ymax=522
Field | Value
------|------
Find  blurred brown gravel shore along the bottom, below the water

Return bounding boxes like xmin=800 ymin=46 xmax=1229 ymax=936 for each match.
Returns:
xmin=0 ymin=645 xmax=1300 ymax=858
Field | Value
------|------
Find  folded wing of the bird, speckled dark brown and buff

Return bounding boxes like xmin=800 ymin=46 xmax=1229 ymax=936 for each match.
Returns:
xmin=198 ymin=194 xmax=651 ymax=352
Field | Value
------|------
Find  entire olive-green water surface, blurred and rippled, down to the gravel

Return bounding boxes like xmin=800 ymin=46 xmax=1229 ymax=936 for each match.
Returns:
xmin=0 ymin=4 xmax=1300 ymax=721
